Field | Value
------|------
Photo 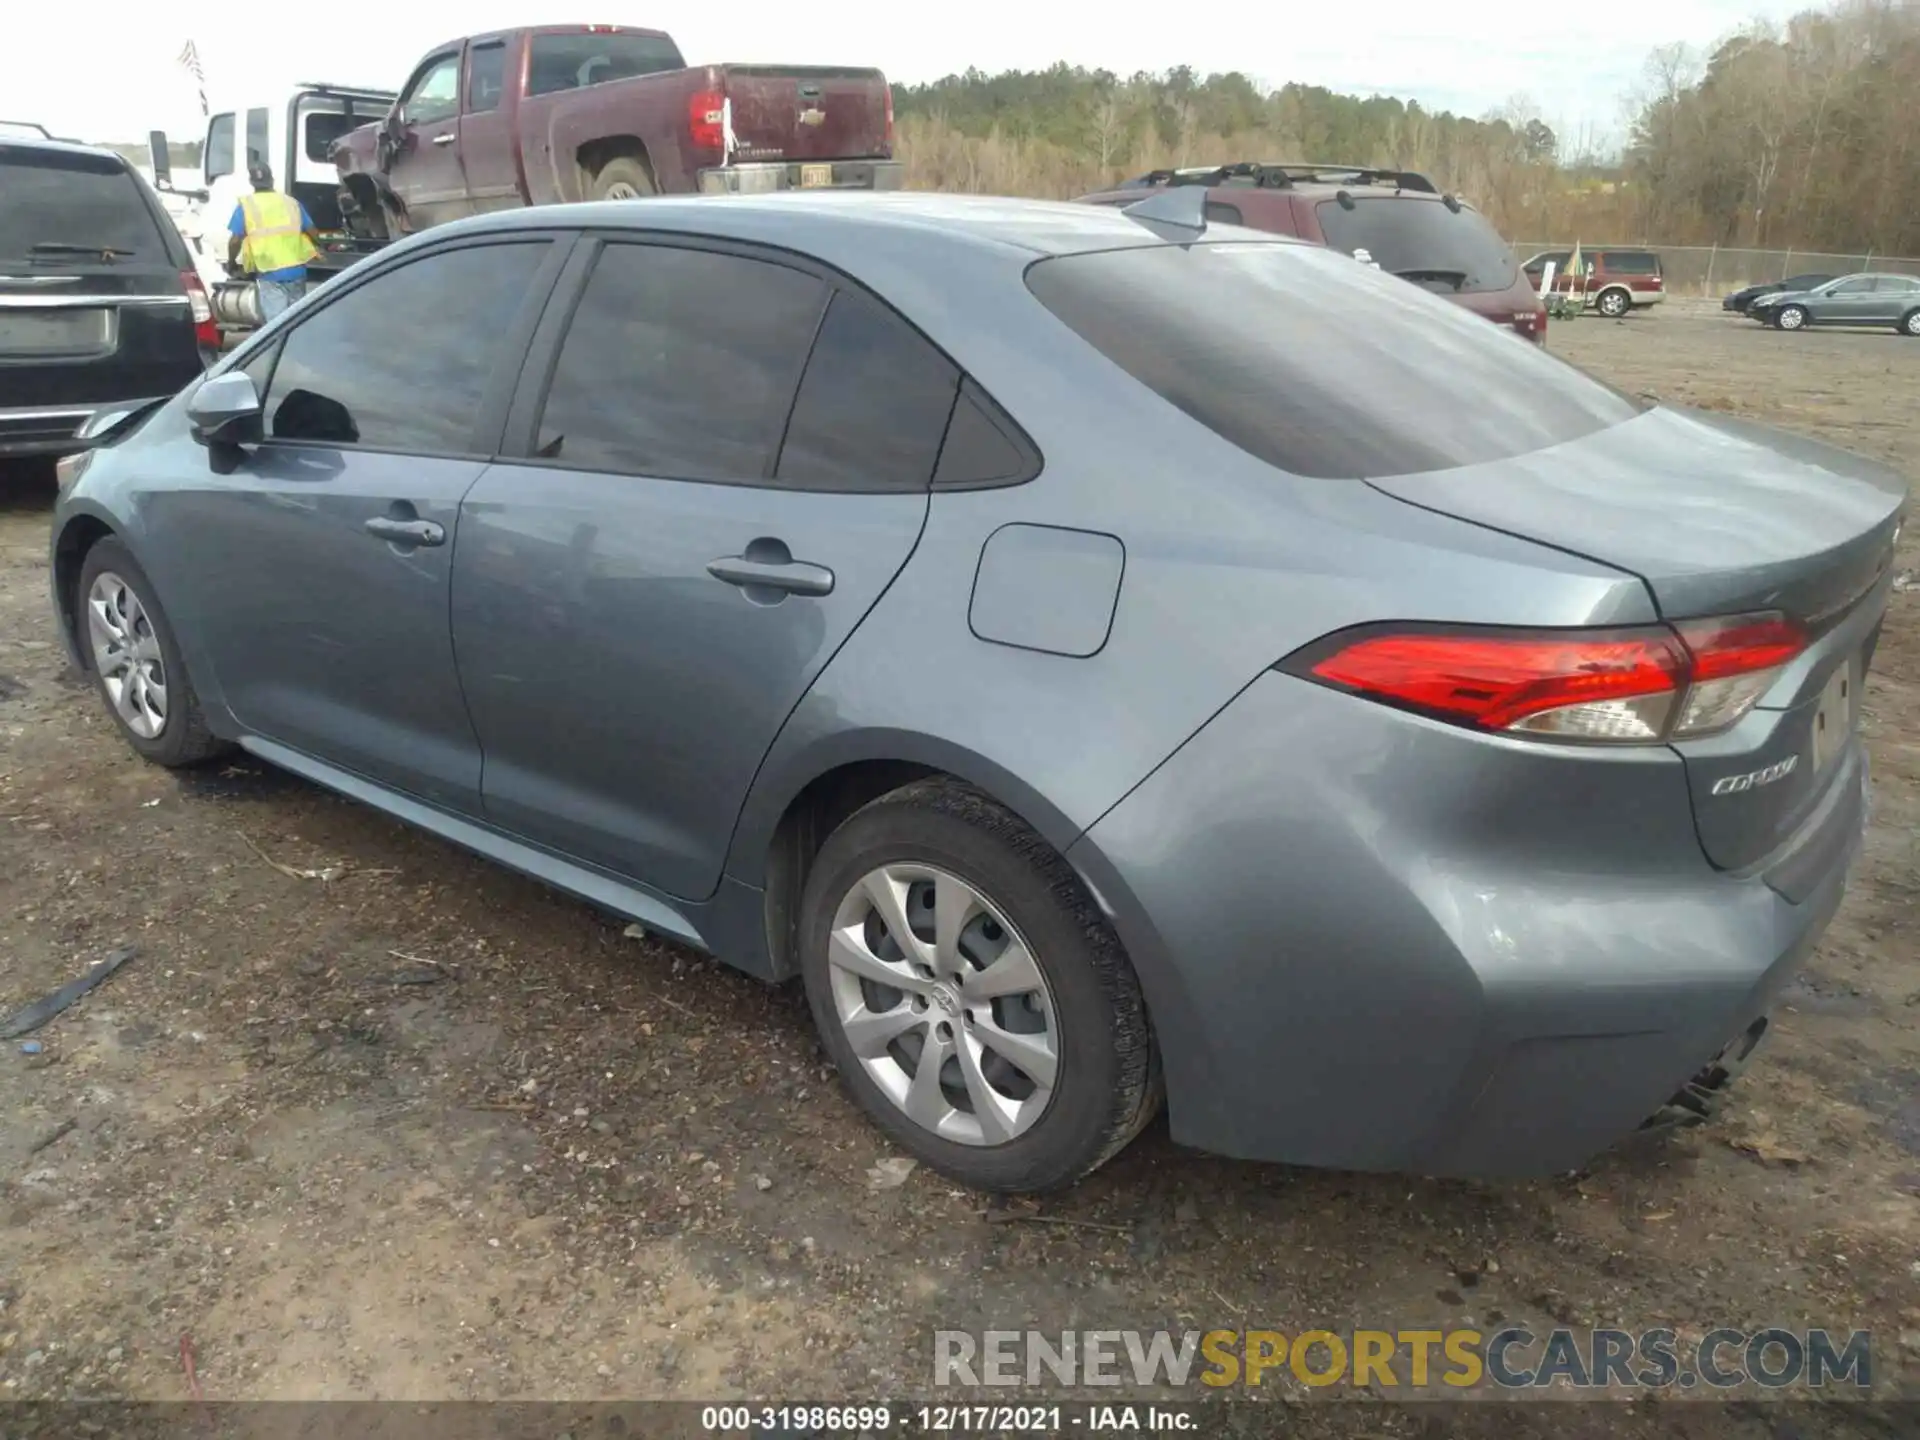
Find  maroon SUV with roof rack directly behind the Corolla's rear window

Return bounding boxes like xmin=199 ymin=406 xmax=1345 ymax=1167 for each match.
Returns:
xmin=1081 ymin=161 xmax=1548 ymax=342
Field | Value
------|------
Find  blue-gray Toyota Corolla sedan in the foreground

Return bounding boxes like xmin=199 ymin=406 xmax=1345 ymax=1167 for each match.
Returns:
xmin=52 ymin=192 xmax=1907 ymax=1190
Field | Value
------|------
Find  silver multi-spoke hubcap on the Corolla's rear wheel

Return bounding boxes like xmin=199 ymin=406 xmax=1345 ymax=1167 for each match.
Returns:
xmin=828 ymin=864 xmax=1060 ymax=1144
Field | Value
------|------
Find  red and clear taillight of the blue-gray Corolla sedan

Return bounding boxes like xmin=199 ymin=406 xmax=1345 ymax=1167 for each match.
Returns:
xmin=1283 ymin=612 xmax=1807 ymax=743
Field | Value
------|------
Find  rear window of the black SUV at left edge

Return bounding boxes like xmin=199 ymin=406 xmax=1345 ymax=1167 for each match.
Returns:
xmin=0 ymin=148 xmax=167 ymax=263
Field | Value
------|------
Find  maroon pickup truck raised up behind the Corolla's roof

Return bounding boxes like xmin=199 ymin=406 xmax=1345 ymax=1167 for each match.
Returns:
xmin=332 ymin=25 xmax=902 ymax=240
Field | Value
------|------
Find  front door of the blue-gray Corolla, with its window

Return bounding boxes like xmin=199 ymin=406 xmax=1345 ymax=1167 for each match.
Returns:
xmin=152 ymin=234 xmax=561 ymax=812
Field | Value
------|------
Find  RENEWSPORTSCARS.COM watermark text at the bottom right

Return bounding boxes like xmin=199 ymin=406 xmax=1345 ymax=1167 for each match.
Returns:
xmin=933 ymin=1327 xmax=1874 ymax=1394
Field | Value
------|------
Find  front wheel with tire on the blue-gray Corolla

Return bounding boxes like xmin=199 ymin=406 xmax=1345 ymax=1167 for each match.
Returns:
xmin=73 ymin=540 xmax=227 ymax=770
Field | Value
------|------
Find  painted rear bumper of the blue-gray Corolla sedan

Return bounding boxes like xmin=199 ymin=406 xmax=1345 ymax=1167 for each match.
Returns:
xmin=1069 ymin=676 xmax=1866 ymax=1177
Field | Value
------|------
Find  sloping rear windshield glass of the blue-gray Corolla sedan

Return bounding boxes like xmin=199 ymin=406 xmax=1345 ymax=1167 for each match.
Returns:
xmin=1027 ymin=240 xmax=1642 ymax=480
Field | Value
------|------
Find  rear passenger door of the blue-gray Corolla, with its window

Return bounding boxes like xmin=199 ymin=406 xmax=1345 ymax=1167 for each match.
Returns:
xmin=453 ymin=240 xmax=958 ymax=899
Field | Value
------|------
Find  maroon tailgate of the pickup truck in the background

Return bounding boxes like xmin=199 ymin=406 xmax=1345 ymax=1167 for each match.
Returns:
xmin=724 ymin=65 xmax=893 ymax=161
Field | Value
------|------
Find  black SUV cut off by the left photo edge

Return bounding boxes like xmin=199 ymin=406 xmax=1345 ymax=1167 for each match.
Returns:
xmin=0 ymin=134 xmax=219 ymax=457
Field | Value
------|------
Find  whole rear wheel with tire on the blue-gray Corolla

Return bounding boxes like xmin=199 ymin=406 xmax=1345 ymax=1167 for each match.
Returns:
xmin=799 ymin=780 xmax=1160 ymax=1194
